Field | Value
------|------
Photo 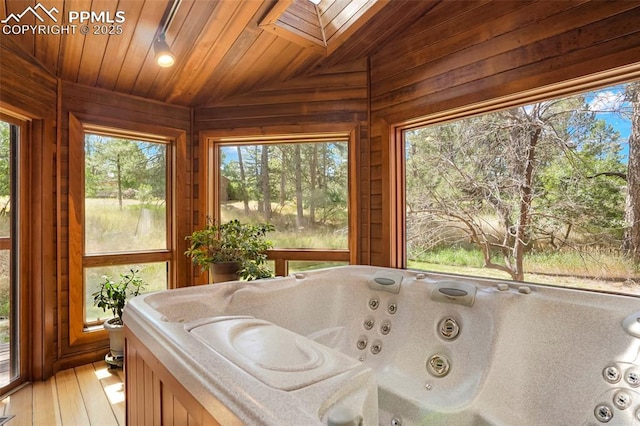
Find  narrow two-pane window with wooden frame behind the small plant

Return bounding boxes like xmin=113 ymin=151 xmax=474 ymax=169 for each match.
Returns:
xmin=69 ymin=116 xmax=174 ymax=341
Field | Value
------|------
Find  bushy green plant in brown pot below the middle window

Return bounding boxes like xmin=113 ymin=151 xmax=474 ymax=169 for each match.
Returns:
xmin=185 ymin=219 xmax=274 ymax=283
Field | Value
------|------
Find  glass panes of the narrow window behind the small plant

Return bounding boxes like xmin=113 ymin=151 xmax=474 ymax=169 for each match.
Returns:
xmin=84 ymin=133 xmax=170 ymax=324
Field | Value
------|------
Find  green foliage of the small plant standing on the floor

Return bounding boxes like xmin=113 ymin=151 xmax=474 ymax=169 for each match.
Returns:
xmin=92 ymin=269 xmax=144 ymax=325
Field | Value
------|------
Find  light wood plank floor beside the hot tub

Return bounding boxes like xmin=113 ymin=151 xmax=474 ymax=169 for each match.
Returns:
xmin=0 ymin=361 xmax=125 ymax=426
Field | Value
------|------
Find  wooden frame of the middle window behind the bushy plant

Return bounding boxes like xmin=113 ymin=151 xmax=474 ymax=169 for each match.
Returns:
xmin=198 ymin=123 xmax=359 ymax=284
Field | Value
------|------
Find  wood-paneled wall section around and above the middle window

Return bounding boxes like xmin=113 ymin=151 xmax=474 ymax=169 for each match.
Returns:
xmin=193 ymin=60 xmax=369 ymax=263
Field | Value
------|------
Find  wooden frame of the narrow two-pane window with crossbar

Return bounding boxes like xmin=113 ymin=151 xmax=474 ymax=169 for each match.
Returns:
xmin=69 ymin=114 xmax=186 ymax=346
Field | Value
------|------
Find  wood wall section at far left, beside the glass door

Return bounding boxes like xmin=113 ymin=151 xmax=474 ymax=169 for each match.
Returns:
xmin=0 ymin=38 xmax=58 ymax=380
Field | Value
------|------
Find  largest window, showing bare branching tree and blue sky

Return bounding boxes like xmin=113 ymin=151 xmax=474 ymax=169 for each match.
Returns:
xmin=403 ymin=82 xmax=640 ymax=294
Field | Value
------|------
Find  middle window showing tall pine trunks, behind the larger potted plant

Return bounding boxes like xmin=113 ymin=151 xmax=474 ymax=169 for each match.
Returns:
xmin=205 ymin=133 xmax=353 ymax=275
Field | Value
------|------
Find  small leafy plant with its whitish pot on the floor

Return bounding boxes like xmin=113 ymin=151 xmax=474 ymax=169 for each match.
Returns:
xmin=92 ymin=269 xmax=144 ymax=365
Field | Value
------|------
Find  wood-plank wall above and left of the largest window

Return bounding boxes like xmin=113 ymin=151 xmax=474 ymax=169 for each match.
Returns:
xmin=368 ymin=1 xmax=640 ymax=266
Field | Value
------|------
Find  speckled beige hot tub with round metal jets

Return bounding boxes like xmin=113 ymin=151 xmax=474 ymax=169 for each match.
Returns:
xmin=124 ymin=266 xmax=640 ymax=426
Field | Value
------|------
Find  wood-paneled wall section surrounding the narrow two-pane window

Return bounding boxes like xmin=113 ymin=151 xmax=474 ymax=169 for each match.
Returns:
xmin=57 ymin=82 xmax=191 ymax=368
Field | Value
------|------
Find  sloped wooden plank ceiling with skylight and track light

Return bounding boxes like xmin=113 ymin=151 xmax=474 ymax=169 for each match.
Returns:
xmin=0 ymin=0 xmax=440 ymax=106
